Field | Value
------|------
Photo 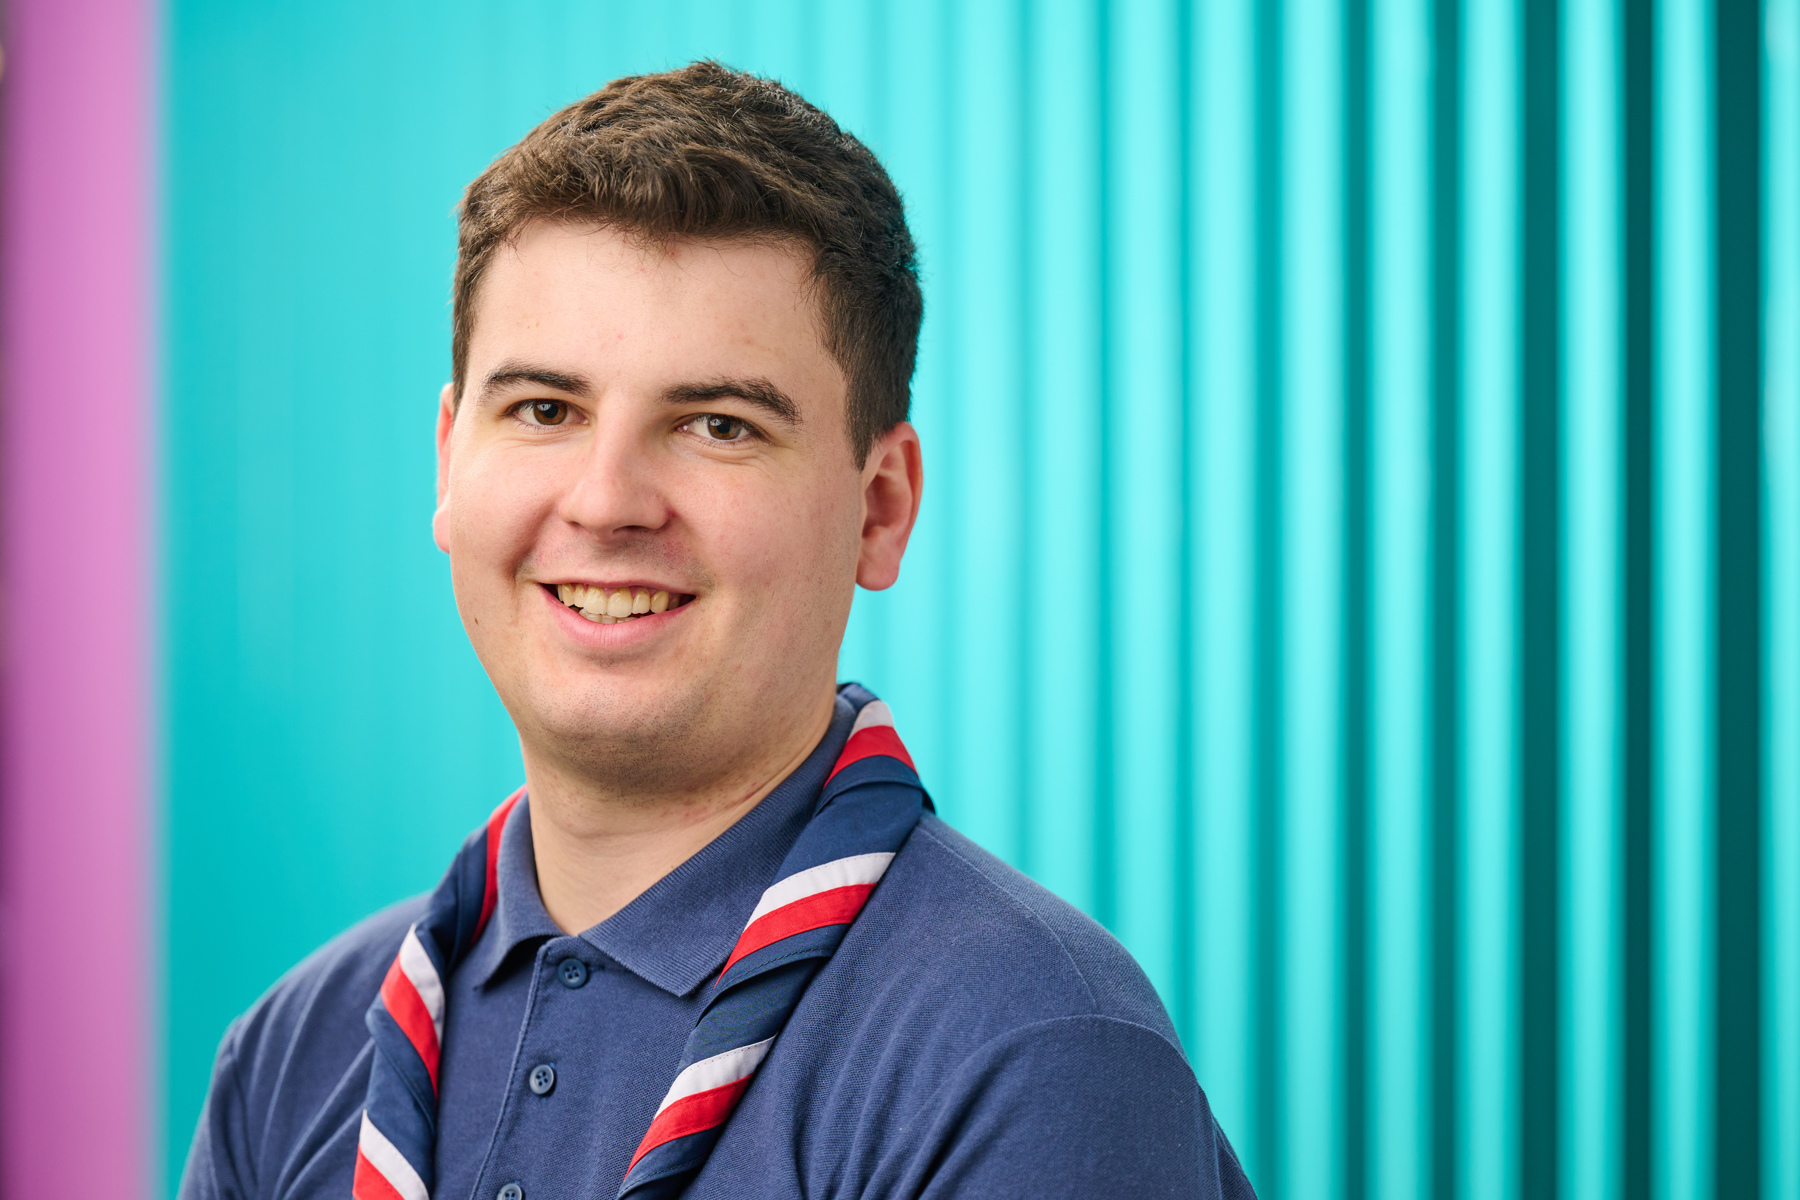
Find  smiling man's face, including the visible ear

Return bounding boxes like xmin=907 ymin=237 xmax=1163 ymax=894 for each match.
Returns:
xmin=434 ymin=223 xmax=918 ymax=792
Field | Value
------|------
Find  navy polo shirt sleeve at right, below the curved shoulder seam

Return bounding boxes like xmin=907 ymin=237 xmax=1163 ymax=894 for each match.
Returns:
xmin=882 ymin=1015 xmax=1255 ymax=1200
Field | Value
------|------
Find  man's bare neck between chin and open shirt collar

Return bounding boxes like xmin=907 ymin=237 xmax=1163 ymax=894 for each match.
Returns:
xmin=524 ymin=693 xmax=835 ymax=934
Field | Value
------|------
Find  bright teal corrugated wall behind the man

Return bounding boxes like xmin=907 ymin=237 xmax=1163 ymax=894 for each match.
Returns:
xmin=162 ymin=0 xmax=1800 ymax=1200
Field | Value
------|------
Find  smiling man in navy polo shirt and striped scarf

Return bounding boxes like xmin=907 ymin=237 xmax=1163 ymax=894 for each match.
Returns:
xmin=182 ymin=63 xmax=1249 ymax=1200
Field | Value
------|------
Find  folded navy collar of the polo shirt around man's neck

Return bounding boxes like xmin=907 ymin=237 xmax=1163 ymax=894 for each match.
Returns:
xmin=468 ymin=696 xmax=855 ymax=997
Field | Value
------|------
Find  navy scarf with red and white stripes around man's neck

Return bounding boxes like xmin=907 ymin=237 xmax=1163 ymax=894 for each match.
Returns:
xmin=351 ymin=684 xmax=927 ymax=1200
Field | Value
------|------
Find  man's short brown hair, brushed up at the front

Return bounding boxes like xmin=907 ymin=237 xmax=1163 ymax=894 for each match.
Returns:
xmin=450 ymin=61 xmax=923 ymax=466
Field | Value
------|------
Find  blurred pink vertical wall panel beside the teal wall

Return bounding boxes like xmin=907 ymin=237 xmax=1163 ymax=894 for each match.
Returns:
xmin=0 ymin=0 xmax=157 ymax=1200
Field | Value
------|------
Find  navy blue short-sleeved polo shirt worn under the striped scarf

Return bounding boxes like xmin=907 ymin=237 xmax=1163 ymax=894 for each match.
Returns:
xmin=180 ymin=700 xmax=1251 ymax=1200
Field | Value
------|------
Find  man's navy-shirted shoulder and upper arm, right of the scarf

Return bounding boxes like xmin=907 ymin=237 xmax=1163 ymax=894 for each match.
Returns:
xmin=745 ymin=815 xmax=1237 ymax=1200
